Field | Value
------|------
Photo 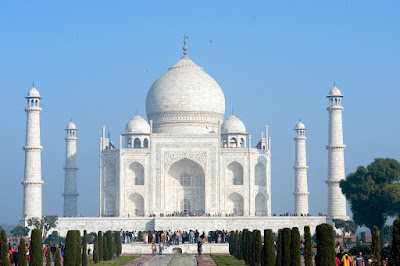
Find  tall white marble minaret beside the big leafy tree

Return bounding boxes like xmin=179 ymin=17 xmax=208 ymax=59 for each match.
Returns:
xmin=326 ymin=86 xmax=349 ymax=220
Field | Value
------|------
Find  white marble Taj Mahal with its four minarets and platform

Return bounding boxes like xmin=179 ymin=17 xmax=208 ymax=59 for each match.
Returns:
xmin=21 ymin=40 xmax=348 ymax=234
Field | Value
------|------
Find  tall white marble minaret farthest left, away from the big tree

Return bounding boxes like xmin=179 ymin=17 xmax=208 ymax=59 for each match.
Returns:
xmin=21 ymin=86 xmax=43 ymax=222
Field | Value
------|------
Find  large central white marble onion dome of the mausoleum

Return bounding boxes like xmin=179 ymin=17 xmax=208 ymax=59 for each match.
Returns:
xmin=146 ymin=55 xmax=225 ymax=133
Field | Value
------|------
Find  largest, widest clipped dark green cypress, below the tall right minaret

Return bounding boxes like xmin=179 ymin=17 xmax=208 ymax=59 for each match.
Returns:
xmin=315 ymin=223 xmax=336 ymax=266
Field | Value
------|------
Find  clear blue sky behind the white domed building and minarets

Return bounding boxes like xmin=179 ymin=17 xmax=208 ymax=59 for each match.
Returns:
xmin=0 ymin=0 xmax=400 ymax=224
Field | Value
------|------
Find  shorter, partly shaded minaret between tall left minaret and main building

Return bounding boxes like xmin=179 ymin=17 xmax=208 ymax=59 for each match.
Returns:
xmin=63 ymin=121 xmax=79 ymax=217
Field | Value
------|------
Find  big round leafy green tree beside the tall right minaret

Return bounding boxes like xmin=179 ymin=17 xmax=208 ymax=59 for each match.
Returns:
xmin=340 ymin=158 xmax=400 ymax=232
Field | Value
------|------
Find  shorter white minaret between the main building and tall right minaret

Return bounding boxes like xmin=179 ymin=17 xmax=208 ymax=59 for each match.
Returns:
xmin=293 ymin=121 xmax=310 ymax=216
